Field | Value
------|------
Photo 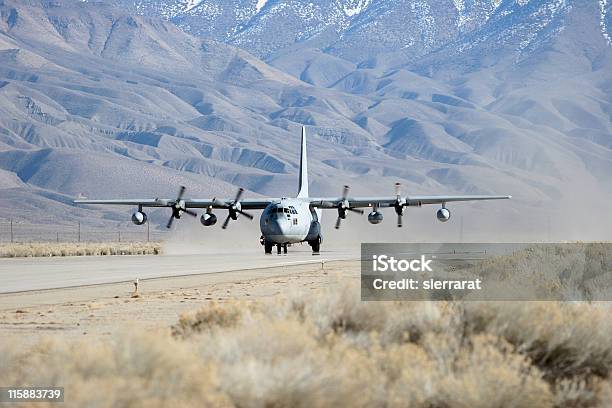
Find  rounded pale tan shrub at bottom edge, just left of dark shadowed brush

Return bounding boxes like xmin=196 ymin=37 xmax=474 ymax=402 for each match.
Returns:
xmin=389 ymin=335 xmax=552 ymax=407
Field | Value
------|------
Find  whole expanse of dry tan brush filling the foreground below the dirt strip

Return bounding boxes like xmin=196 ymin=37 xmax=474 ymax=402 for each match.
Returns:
xmin=0 ymin=284 xmax=612 ymax=408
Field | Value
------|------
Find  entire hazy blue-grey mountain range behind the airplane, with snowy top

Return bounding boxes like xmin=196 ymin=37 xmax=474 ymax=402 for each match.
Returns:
xmin=0 ymin=0 xmax=612 ymax=239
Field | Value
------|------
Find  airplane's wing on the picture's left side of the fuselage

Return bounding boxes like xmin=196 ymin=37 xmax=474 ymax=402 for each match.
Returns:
xmin=74 ymin=198 xmax=272 ymax=210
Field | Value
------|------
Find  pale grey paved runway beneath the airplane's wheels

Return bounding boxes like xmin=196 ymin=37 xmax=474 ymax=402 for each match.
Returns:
xmin=0 ymin=250 xmax=359 ymax=293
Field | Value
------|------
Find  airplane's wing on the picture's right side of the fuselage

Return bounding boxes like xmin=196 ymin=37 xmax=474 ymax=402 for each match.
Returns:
xmin=310 ymin=195 xmax=512 ymax=208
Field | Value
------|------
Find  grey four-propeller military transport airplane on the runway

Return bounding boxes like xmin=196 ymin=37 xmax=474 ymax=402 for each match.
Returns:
xmin=75 ymin=127 xmax=511 ymax=254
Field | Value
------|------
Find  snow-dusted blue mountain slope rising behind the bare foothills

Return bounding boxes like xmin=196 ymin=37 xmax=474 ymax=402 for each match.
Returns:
xmin=107 ymin=0 xmax=612 ymax=62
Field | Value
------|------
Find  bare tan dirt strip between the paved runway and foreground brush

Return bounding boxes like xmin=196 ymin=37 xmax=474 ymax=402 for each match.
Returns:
xmin=0 ymin=258 xmax=359 ymax=343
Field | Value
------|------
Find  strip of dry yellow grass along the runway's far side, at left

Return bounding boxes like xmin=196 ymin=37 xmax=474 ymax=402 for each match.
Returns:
xmin=0 ymin=242 xmax=161 ymax=258
